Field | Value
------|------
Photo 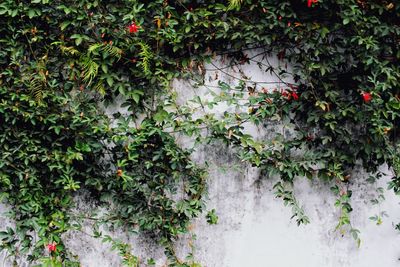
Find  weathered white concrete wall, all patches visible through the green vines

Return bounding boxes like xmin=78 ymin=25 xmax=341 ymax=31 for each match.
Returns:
xmin=0 ymin=52 xmax=400 ymax=267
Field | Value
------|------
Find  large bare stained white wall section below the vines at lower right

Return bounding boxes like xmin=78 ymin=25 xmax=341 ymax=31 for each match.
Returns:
xmin=188 ymin=153 xmax=400 ymax=267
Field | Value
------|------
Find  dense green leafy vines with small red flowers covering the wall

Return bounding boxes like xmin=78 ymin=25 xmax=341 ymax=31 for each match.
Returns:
xmin=0 ymin=0 xmax=400 ymax=266
